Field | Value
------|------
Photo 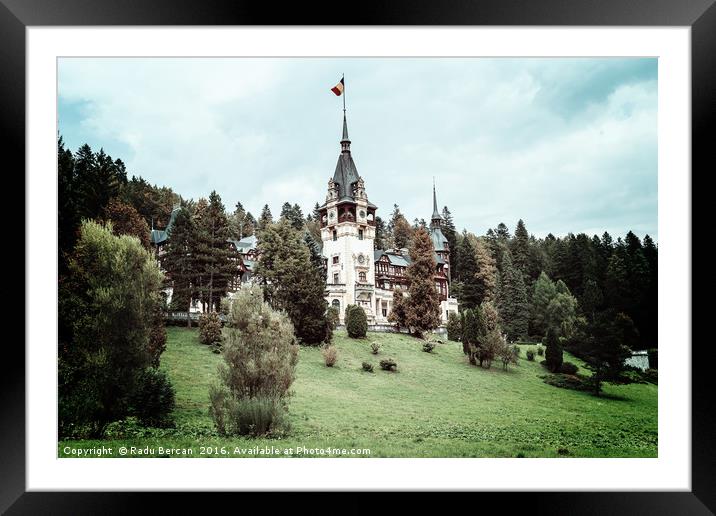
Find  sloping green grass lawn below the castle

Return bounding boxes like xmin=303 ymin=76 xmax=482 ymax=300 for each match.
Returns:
xmin=59 ymin=327 xmax=657 ymax=457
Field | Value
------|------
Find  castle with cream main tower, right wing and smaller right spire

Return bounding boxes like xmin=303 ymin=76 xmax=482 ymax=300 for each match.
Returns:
xmin=320 ymin=112 xmax=458 ymax=325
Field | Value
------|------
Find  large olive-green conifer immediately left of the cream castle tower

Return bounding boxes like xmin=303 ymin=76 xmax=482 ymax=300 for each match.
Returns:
xmin=256 ymin=220 xmax=332 ymax=345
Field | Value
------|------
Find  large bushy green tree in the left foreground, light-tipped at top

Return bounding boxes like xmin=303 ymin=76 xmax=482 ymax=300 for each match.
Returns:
xmin=58 ymin=222 xmax=167 ymax=436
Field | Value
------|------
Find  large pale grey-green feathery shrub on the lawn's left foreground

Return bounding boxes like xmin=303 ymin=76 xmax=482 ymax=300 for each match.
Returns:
xmin=209 ymin=285 xmax=298 ymax=435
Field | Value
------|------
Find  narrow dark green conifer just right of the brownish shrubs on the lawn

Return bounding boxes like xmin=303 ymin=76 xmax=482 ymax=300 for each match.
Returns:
xmin=498 ymin=250 xmax=529 ymax=341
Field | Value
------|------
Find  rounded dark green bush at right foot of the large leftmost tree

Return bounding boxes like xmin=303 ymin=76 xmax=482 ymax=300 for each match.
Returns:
xmin=130 ymin=367 xmax=175 ymax=427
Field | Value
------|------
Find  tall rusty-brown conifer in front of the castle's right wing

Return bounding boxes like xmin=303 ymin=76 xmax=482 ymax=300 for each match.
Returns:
xmin=405 ymin=228 xmax=440 ymax=336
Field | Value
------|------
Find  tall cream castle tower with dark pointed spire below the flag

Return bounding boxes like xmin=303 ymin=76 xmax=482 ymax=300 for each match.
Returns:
xmin=319 ymin=110 xmax=377 ymax=322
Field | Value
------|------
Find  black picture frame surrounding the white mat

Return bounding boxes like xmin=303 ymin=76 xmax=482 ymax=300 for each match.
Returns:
xmin=0 ymin=0 xmax=716 ymax=515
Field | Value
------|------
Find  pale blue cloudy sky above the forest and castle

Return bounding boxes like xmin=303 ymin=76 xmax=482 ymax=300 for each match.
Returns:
xmin=58 ymin=58 xmax=658 ymax=238
